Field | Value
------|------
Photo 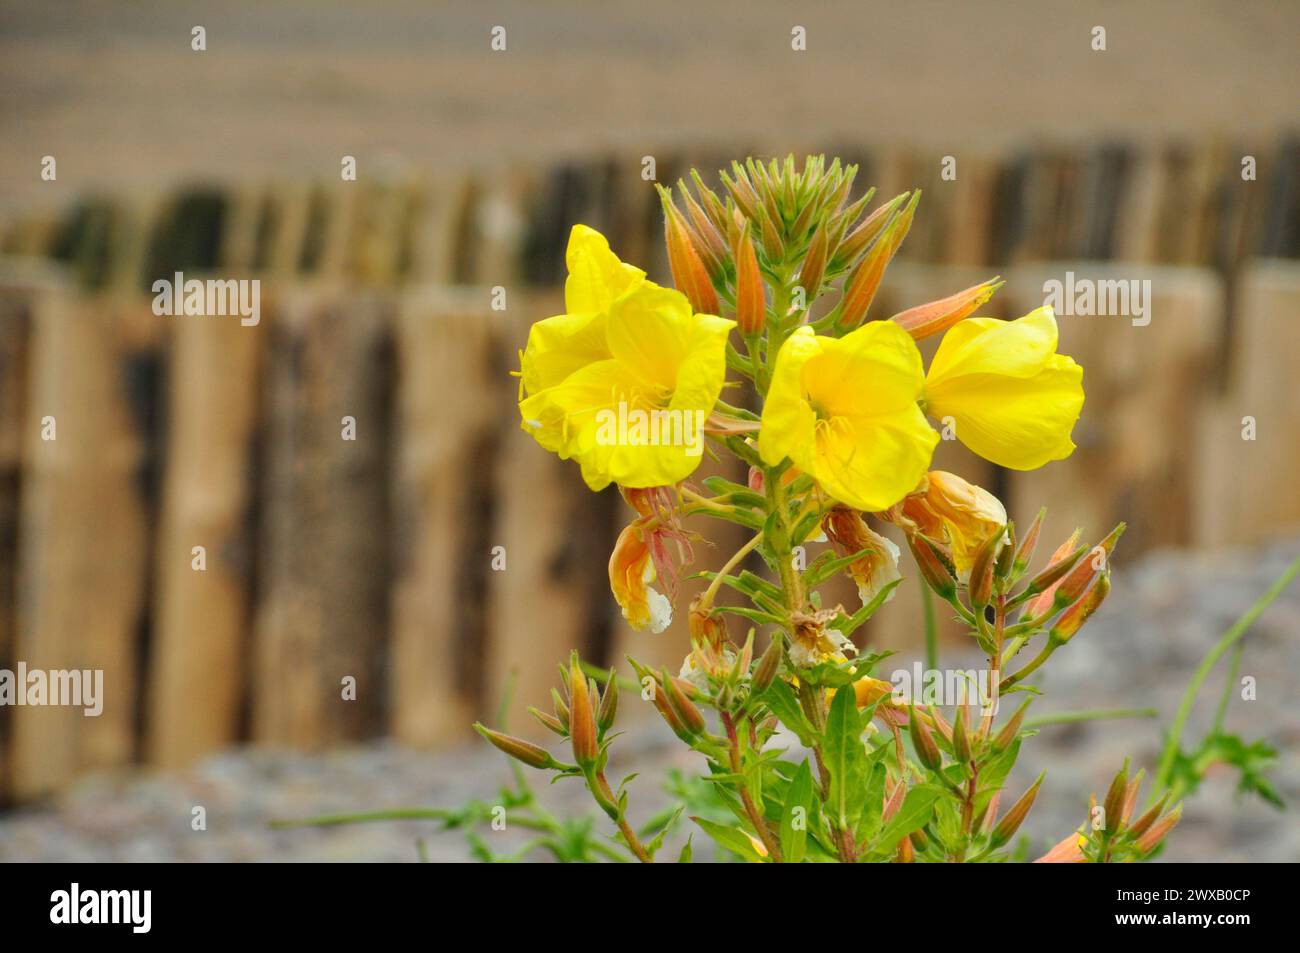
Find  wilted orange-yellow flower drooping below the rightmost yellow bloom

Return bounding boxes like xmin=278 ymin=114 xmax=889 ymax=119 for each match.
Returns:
xmin=885 ymin=469 xmax=1006 ymax=581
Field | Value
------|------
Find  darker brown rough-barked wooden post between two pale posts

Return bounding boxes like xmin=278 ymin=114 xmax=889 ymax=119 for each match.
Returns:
xmin=252 ymin=294 xmax=391 ymax=748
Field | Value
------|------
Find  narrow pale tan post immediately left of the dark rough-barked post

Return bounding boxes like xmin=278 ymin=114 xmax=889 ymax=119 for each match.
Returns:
xmin=148 ymin=310 xmax=267 ymax=767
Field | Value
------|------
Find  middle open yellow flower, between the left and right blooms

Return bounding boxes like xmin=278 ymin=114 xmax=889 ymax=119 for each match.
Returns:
xmin=758 ymin=321 xmax=939 ymax=511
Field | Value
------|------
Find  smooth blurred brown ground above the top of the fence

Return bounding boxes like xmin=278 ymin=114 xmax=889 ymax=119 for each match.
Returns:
xmin=0 ymin=0 xmax=1300 ymax=211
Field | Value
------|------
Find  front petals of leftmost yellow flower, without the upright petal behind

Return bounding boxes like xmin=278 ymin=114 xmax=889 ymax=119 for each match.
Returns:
xmin=535 ymin=282 xmax=736 ymax=490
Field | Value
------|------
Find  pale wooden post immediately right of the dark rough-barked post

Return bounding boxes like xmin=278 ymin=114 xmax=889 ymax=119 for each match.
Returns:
xmin=389 ymin=289 xmax=493 ymax=745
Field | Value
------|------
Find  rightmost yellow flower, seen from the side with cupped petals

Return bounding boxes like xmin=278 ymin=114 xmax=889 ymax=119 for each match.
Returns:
xmin=926 ymin=308 xmax=1083 ymax=469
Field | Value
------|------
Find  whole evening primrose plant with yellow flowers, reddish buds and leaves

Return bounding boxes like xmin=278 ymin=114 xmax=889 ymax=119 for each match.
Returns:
xmin=480 ymin=157 xmax=1177 ymax=862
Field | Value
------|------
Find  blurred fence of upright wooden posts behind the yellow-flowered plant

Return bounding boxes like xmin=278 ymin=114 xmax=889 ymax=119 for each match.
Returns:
xmin=0 ymin=144 xmax=1300 ymax=800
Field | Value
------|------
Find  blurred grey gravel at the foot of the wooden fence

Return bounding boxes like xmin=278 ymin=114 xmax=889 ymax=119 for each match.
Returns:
xmin=0 ymin=541 xmax=1300 ymax=862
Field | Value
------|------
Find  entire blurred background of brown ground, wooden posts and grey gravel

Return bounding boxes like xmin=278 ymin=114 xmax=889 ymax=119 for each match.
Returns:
xmin=0 ymin=0 xmax=1300 ymax=859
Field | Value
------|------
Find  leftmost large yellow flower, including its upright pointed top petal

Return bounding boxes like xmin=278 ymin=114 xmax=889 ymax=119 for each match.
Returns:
xmin=519 ymin=226 xmax=736 ymax=490
